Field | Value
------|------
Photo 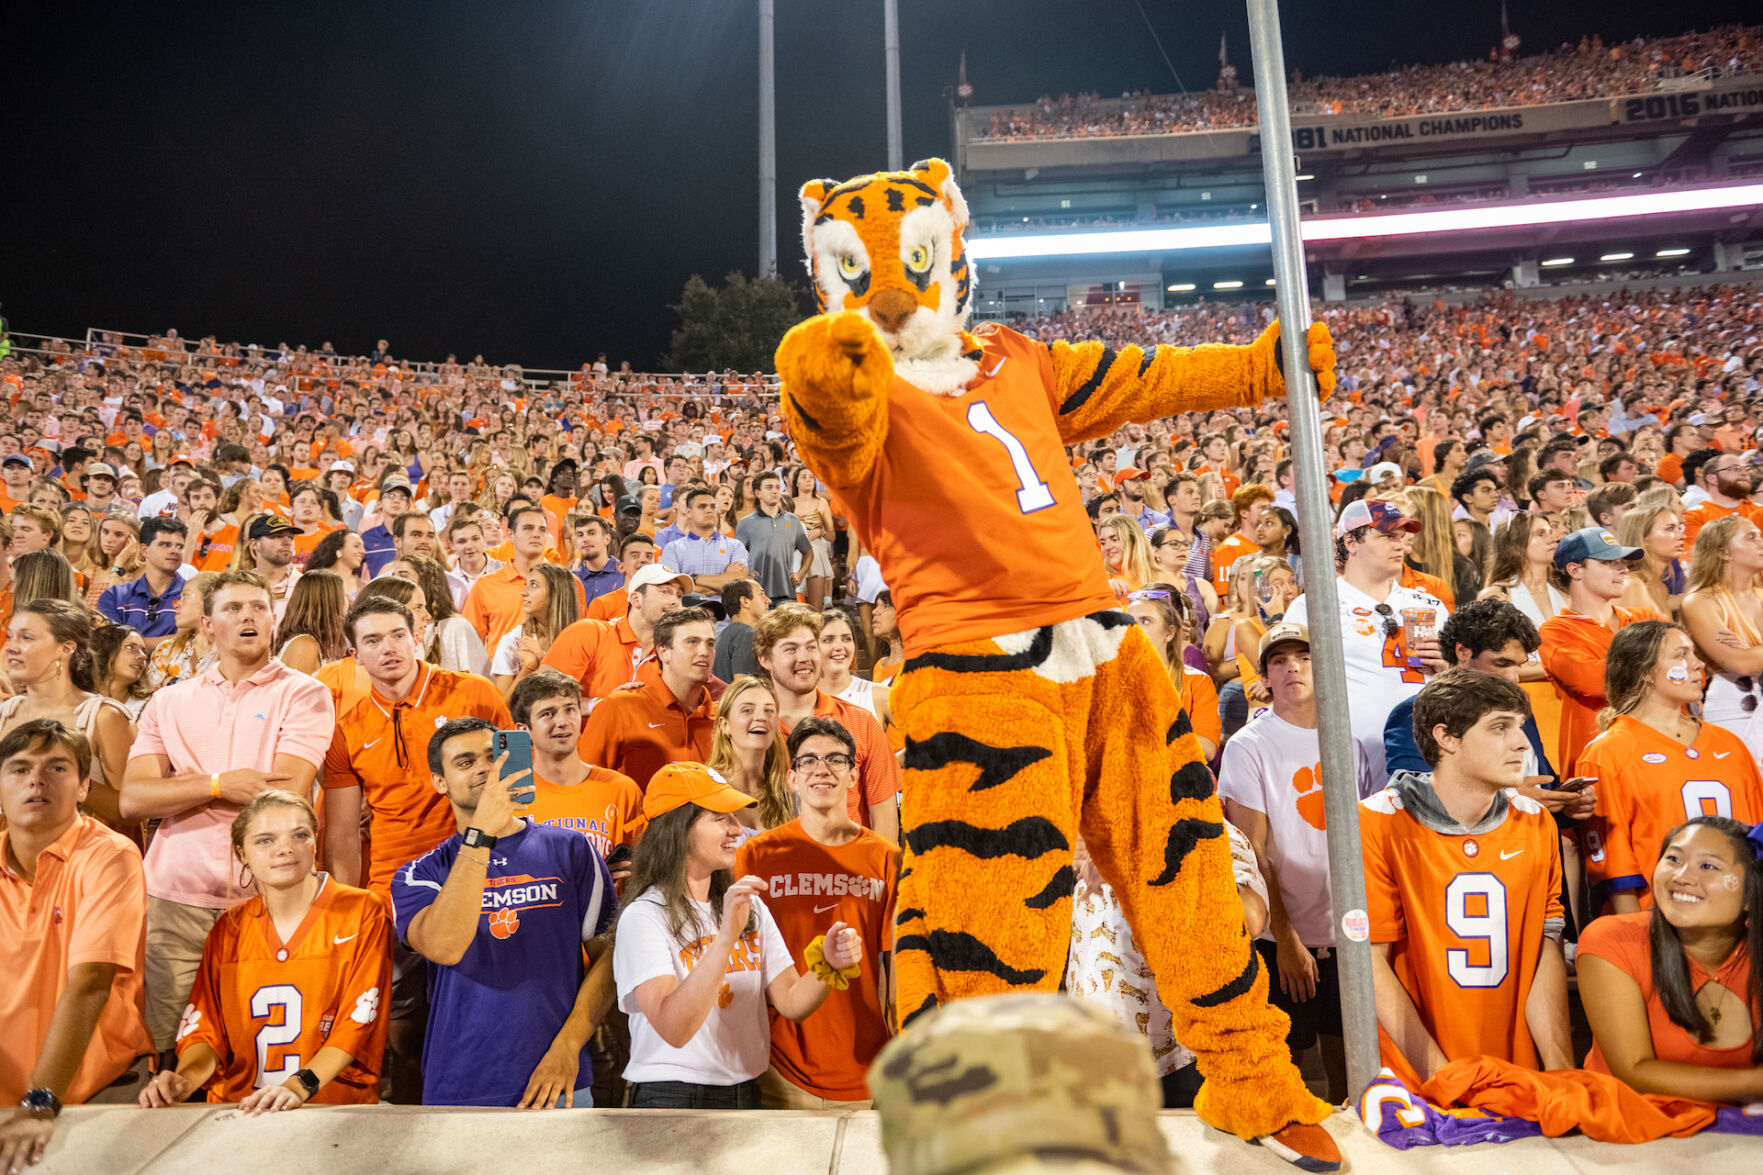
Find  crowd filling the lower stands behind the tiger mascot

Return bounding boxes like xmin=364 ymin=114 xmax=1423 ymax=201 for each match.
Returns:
xmin=0 ymin=275 xmax=1763 ymax=1166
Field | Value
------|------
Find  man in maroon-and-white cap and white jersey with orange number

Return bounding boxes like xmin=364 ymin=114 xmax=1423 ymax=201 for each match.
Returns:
xmin=1285 ymin=499 xmax=1447 ymax=782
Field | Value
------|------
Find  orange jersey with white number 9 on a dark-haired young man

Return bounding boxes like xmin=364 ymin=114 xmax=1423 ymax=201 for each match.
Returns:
xmin=1359 ymin=787 xmax=1564 ymax=1069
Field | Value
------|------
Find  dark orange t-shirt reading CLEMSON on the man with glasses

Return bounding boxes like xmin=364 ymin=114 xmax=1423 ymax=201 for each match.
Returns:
xmin=735 ymin=820 xmax=899 ymax=1101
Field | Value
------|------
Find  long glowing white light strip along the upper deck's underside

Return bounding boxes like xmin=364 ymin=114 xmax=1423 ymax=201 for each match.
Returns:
xmin=968 ymin=183 xmax=1763 ymax=261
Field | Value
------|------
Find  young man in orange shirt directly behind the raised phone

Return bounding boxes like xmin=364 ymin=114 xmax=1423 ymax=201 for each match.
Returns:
xmin=508 ymin=669 xmax=647 ymax=889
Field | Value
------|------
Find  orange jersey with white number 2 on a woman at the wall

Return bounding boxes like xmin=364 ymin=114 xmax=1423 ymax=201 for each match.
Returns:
xmin=178 ymin=877 xmax=391 ymax=1106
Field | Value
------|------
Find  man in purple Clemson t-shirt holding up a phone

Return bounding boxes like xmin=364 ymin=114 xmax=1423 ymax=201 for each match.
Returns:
xmin=391 ymin=718 xmax=617 ymax=1110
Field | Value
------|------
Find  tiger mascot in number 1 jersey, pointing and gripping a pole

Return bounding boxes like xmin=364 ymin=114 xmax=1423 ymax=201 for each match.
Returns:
xmin=777 ymin=159 xmax=1338 ymax=1170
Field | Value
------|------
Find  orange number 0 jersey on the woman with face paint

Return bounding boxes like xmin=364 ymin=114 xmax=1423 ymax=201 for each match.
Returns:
xmin=1573 ymin=715 xmax=1763 ymax=907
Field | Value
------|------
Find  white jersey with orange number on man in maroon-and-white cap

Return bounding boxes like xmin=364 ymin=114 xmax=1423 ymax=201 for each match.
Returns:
xmin=1285 ymin=579 xmax=1451 ymax=783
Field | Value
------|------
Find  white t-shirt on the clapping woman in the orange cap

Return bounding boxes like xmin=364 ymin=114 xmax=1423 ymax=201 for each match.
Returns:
xmin=612 ymin=889 xmax=795 ymax=1085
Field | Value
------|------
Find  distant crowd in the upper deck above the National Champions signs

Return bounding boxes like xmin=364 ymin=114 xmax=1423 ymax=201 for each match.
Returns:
xmin=977 ymin=25 xmax=1763 ymax=141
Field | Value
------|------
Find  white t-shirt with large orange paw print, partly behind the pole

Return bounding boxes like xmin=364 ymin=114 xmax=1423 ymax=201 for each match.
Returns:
xmin=1218 ymin=709 xmax=1384 ymax=947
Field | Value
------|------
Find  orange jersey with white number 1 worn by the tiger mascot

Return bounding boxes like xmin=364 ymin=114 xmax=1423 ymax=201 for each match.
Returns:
xmin=836 ymin=326 xmax=1118 ymax=656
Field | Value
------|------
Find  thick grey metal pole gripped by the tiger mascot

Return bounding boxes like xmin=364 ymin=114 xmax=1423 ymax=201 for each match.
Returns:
xmin=1248 ymin=0 xmax=1379 ymax=1096
